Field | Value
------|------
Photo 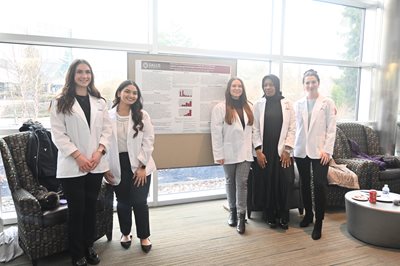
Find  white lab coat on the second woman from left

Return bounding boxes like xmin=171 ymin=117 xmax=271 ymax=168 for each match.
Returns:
xmin=108 ymin=107 xmax=156 ymax=185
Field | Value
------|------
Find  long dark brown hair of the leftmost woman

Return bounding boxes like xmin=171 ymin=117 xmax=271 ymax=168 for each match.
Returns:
xmin=57 ymin=59 xmax=102 ymax=114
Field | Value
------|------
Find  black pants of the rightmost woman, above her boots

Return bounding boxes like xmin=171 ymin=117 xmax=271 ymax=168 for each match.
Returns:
xmin=295 ymin=156 xmax=328 ymax=220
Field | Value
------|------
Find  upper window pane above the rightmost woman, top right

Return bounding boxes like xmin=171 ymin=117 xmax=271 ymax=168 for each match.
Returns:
xmin=284 ymin=0 xmax=363 ymax=60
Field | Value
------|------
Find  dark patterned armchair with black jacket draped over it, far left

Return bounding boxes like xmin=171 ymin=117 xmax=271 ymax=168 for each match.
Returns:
xmin=0 ymin=132 xmax=113 ymax=265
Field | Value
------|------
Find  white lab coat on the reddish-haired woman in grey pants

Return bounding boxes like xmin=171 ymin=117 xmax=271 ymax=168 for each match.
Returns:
xmin=211 ymin=102 xmax=253 ymax=164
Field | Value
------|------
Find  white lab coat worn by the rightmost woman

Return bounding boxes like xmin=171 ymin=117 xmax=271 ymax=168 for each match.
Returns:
xmin=294 ymin=95 xmax=336 ymax=159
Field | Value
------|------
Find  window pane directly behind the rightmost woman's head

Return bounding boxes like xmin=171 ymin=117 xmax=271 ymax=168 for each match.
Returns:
xmin=282 ymin=64 xmax=359 ymax=120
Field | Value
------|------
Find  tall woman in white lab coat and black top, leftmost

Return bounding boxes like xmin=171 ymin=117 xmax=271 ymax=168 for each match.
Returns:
xmin=50 ymin=59 xmax=112 ymax=265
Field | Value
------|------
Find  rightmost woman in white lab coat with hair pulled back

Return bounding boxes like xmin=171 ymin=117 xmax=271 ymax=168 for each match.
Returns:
xmin=294 ymin=69 xmax=336 ymax=240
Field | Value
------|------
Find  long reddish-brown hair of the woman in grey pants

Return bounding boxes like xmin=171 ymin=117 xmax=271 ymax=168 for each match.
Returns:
xmin=225 ymin=77 xmax=254 ymax=126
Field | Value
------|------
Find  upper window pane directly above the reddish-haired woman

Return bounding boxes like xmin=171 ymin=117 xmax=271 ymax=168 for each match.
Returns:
xmin=158 ymin=0 xmax=272 ymax=53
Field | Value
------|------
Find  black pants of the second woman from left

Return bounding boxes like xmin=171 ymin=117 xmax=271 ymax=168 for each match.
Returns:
xmin=114 ymin=152 xmax=151 ymax=239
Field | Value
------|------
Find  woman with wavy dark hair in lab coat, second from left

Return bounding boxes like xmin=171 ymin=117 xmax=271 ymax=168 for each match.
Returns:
xmin=105 ymin=80 xmax=156 ymax=253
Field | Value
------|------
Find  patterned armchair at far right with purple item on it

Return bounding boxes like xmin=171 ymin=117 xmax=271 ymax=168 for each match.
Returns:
xmin=338 ymin=123 xmax=400 ymax=193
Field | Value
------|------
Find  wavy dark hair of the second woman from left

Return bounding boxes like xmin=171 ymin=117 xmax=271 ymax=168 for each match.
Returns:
xmin=112 ymin=79 xmax=144 ymax=138
